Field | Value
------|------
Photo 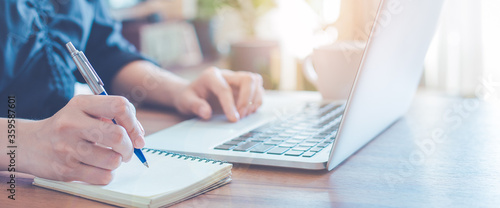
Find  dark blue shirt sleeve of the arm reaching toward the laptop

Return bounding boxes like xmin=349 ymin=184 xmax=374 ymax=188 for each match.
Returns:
xmin=85 ymin=1 xmax=151 ymax=93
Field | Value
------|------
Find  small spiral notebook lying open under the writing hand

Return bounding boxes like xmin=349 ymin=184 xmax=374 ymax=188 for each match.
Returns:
xmin=33 ymin=149 xmax=232 ymax=207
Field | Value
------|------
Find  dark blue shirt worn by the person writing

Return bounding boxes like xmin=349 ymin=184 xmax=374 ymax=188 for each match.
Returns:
xmin=0 ymin=0 xmax=145 ymax=119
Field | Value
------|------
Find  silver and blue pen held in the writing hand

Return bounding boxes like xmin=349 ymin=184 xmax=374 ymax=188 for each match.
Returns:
xmin=66 ymin=42 xmax=149 ymax=168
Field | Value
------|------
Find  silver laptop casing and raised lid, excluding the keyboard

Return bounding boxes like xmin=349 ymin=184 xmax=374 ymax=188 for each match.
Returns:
xmin=146 ymin=0 xmax=443 ymax=170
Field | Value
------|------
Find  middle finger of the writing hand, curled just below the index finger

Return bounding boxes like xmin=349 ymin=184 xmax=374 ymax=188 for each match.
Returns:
xmin=77 ymin=117 xmax=133 ymax=162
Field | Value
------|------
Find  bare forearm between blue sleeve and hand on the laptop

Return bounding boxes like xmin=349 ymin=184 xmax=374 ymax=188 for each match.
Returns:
xmin=111 ymin=61 xmax=188 ymax=107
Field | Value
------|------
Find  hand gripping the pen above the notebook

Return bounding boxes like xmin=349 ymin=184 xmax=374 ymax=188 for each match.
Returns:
xmin=19 ymin=95 xmax=145 ymax=184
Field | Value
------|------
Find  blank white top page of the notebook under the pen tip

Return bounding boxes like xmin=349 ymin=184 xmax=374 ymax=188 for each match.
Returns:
xmin=101 ymin=153 xmax=230 ymax=197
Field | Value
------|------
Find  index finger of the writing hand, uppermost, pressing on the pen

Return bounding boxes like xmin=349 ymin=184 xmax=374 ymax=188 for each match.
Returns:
xmin=72 ymin=95 xmax=144 ymax=148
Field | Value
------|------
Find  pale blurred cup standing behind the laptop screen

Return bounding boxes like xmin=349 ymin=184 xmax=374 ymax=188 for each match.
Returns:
xmin=302 ymin=41 xmax=366 ymax=100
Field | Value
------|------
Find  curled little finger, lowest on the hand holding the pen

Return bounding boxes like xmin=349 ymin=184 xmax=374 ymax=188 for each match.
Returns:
xmin=75 ymin=140 xmax=122 ymax=170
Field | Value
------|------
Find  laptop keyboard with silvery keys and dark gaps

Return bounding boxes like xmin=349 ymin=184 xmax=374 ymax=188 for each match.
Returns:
xmin=214 ymin=103 xmax=345 ymax=157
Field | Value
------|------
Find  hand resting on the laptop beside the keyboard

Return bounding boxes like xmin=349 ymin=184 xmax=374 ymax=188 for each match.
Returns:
xmin=174 ymin=67 xmax=264 ymax=122
